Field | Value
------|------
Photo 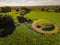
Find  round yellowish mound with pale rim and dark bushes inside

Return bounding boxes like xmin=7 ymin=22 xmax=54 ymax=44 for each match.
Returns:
xmin=32 ymin=19 xmax=59 ymax=34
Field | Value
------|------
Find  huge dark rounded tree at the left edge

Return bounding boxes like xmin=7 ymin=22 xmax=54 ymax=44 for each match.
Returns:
xmin=0 ymin=15 xmax=16 ymax=36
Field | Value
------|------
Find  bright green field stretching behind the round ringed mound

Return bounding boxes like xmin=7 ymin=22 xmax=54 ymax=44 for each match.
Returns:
xmin=25 ymin=11 xmax=60 ymax=25
